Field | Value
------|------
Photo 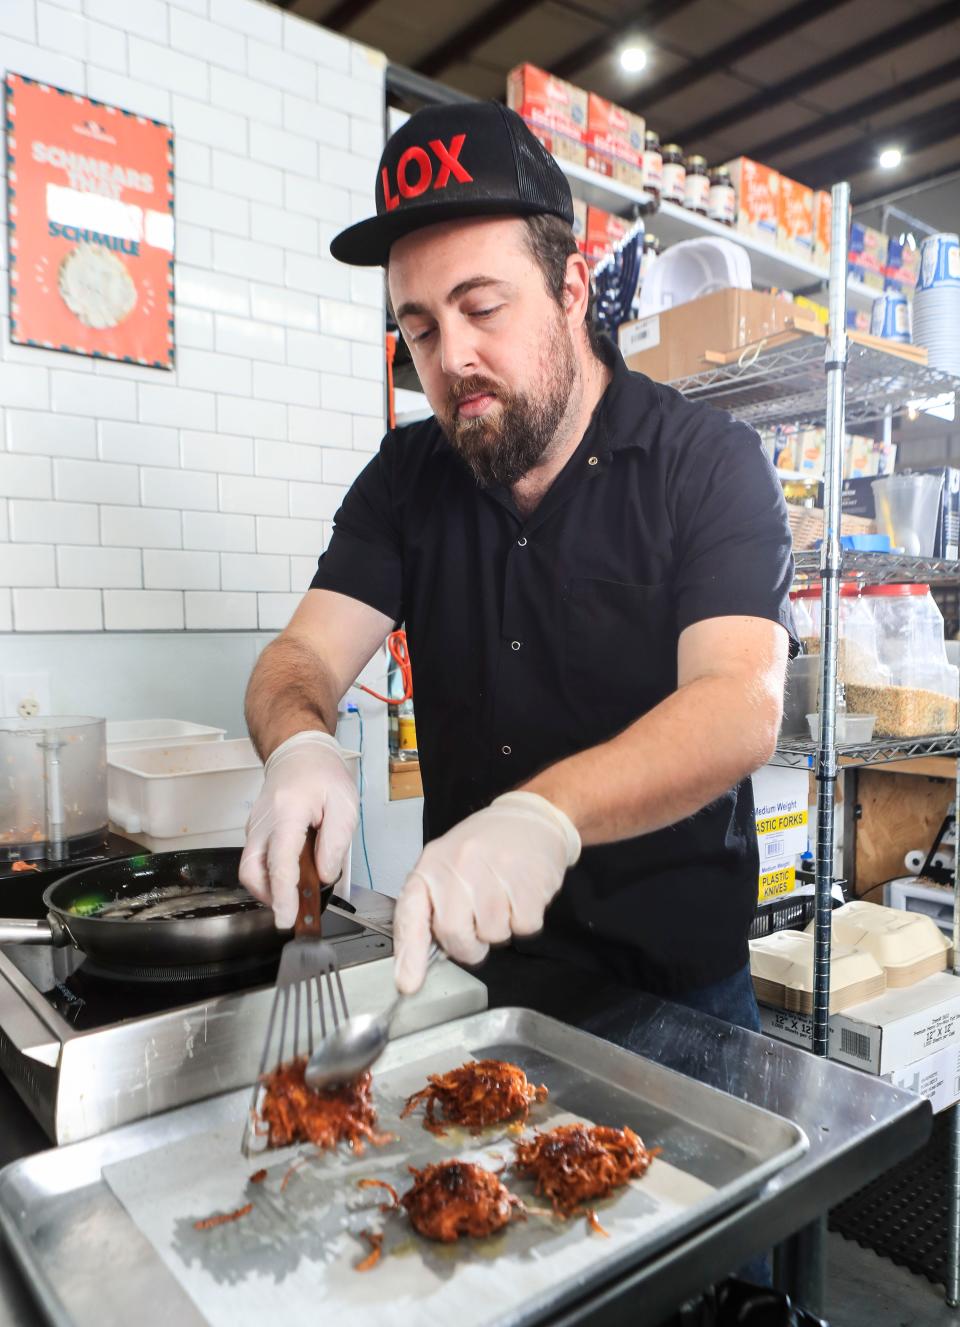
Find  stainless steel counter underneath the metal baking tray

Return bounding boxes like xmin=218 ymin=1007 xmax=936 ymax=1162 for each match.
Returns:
xmin=0 ymin=897 xmax=931 ymax=1327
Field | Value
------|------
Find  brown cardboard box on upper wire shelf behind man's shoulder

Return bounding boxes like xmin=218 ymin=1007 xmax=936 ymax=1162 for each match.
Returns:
xmin=619 ymin=289 xmax=794 ymax=382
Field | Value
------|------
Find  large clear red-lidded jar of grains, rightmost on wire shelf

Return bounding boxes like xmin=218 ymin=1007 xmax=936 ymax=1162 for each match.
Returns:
xmin=858 ymin=585 xmax=960 ymax=738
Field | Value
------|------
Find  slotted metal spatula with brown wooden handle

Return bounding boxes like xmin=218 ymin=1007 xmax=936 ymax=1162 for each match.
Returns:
xmin=240 ymin=829 xmax=349 ymax=1157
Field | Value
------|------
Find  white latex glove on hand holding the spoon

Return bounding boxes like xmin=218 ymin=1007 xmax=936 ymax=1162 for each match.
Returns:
xmin=393 ymin=792 xmax=580 ymax=995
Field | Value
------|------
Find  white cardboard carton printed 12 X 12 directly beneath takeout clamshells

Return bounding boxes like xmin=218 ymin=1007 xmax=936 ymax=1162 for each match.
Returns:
xmin=760 ymin=973 xmax=960 ymax=1075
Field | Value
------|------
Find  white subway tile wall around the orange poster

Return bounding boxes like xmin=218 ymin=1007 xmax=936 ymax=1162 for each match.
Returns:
xmin=0 ymin=0 xmax=385 ymax=632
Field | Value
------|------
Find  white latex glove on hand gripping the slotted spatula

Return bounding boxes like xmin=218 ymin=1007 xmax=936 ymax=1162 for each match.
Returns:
xmin=239 ymin=733 xmax=360 ymax=930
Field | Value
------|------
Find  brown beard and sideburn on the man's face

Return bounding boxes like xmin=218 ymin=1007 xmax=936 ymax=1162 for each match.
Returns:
xmin=437 ymin=310 xmax=576 ymax=488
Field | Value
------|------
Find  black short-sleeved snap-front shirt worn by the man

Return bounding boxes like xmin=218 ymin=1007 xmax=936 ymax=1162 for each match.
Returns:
xmin=312 ymin=345 xmax=793 ymax=994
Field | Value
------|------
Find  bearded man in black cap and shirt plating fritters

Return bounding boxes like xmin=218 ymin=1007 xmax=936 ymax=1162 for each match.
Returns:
xmin=240 ymin=104 xmax=793 ymax=1030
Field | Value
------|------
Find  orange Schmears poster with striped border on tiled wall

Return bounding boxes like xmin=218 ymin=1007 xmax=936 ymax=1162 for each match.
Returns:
xmin=5 ymin=74 xmax=174 ymax=369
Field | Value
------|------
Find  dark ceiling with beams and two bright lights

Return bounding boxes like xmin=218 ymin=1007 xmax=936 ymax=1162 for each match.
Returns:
xmin=274 ymin=0 xmax=960 ymax=214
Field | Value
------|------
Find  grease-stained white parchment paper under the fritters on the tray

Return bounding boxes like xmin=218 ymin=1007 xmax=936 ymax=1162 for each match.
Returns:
xmin=104 ymin=1055 xmax=714 ymax=1327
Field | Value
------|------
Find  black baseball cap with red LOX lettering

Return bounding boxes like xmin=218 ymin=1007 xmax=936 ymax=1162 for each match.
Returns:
xmin=331 ymin=101 xmax=574 ymax=267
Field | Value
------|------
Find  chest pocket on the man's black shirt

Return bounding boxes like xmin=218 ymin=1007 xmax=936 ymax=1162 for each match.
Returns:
xmin=564 ymin=577 xmax=677 ymax=740
